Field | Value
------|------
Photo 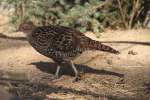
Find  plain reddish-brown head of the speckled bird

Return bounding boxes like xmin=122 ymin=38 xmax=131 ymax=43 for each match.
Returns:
xmin=17 ymin=21 xmax=36 ymax=35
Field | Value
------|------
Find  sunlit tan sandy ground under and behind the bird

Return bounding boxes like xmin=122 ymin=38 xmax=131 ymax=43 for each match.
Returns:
xmin=0 ymin=29 xmax=150 ymax=100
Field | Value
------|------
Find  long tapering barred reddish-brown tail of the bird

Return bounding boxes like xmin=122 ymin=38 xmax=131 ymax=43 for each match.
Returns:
xmin=85 ymin=39 xmax=119 ymax=54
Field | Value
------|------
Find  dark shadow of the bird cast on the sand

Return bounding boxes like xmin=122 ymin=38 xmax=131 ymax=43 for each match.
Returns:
xmin=31 ymin=62 xmax=124 ymax=77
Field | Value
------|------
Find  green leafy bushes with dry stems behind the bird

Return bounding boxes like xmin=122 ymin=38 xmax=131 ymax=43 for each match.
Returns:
xmin=0 ymin=0 xmax=149 ymax=33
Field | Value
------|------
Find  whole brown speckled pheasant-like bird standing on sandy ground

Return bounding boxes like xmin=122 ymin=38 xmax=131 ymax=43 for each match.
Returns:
xmin=18 ymin=21 xmax=119 ymax=80
